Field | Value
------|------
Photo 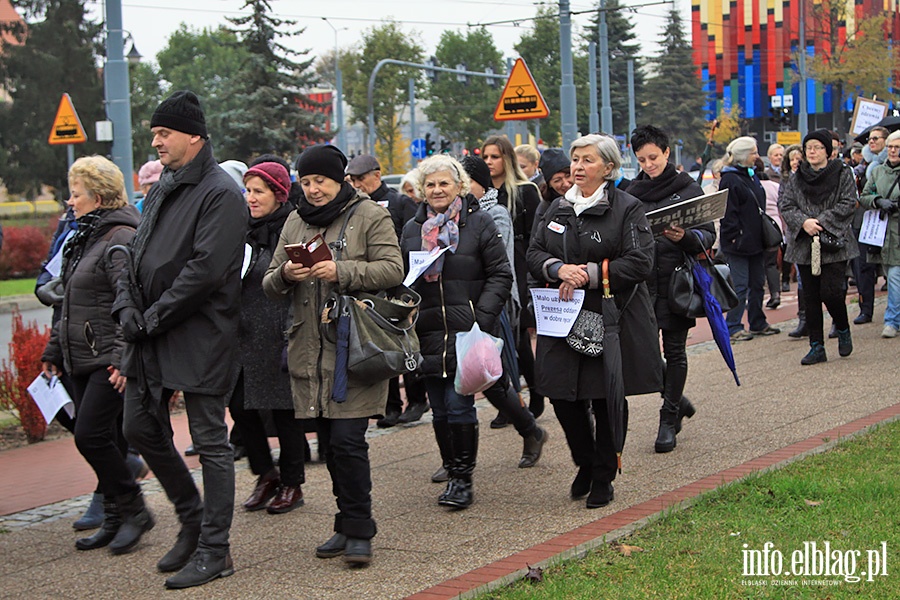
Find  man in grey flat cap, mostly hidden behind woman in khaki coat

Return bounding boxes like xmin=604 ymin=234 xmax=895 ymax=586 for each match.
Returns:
xmin=347 ymin=154 xmax=428 ymax=427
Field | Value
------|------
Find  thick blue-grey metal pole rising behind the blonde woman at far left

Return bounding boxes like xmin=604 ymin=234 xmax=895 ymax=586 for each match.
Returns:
xmin=103 ymin=0 xmax=134 ymax=202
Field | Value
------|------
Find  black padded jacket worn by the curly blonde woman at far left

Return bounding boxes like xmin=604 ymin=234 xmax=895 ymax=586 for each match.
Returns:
xmin=41 ymin=206 xmax=141 ymax=375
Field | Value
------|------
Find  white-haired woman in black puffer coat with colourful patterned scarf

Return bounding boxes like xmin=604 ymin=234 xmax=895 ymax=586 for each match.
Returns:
xmin=400 ymin=155 xmax=512 ymax=508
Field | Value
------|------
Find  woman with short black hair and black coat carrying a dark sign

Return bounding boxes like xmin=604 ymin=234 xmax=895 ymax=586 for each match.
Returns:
xmin=628 ymin=125 xmax=716 ymax=452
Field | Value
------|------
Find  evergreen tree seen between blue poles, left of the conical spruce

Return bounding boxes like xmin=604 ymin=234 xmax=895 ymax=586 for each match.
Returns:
xmin=583 ymin=0 xmax=644 ymax=137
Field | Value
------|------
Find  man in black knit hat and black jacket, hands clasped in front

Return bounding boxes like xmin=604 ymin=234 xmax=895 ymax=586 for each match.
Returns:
xmin=113 ymin=91 xmax=247 ymax=588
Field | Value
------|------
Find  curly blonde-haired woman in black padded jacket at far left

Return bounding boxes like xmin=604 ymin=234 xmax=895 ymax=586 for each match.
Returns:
xmin=41 ymin=156 xmax=155 ymax=554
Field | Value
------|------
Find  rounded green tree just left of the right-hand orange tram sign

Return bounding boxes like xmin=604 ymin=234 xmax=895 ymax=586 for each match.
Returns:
xmin=425 ymin=28 xmax=506 ymax=148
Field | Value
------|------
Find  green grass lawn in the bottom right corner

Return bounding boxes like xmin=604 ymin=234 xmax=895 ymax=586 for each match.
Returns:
xmin=481 ymin=421 xmax=900 ymax=600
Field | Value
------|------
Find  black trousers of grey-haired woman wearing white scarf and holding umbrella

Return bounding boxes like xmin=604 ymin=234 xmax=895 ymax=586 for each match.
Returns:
xmin=550 ymin=398 xmax=628 ymax=481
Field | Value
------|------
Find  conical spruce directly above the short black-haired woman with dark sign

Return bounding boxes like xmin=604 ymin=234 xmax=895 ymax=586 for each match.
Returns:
xmin=638 ymin=10 xmax=707 ymax=155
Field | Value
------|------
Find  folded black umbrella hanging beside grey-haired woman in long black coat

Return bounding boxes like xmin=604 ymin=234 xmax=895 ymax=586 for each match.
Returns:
xmin=601 ymin=258 xmax=628 ymax=473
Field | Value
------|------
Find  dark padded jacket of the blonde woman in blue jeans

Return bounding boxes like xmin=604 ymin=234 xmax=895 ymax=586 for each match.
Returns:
xmin=719 ymin=165 xmax=766 ymax=256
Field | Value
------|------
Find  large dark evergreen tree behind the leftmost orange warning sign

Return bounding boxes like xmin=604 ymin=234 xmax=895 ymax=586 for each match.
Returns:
xmin=0 ymin=0 xmax=105 ymax=199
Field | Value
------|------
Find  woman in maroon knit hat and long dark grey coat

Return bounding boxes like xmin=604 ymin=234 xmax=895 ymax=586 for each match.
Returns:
xmin=229 ymin=162 xmax=306 ymax=514
